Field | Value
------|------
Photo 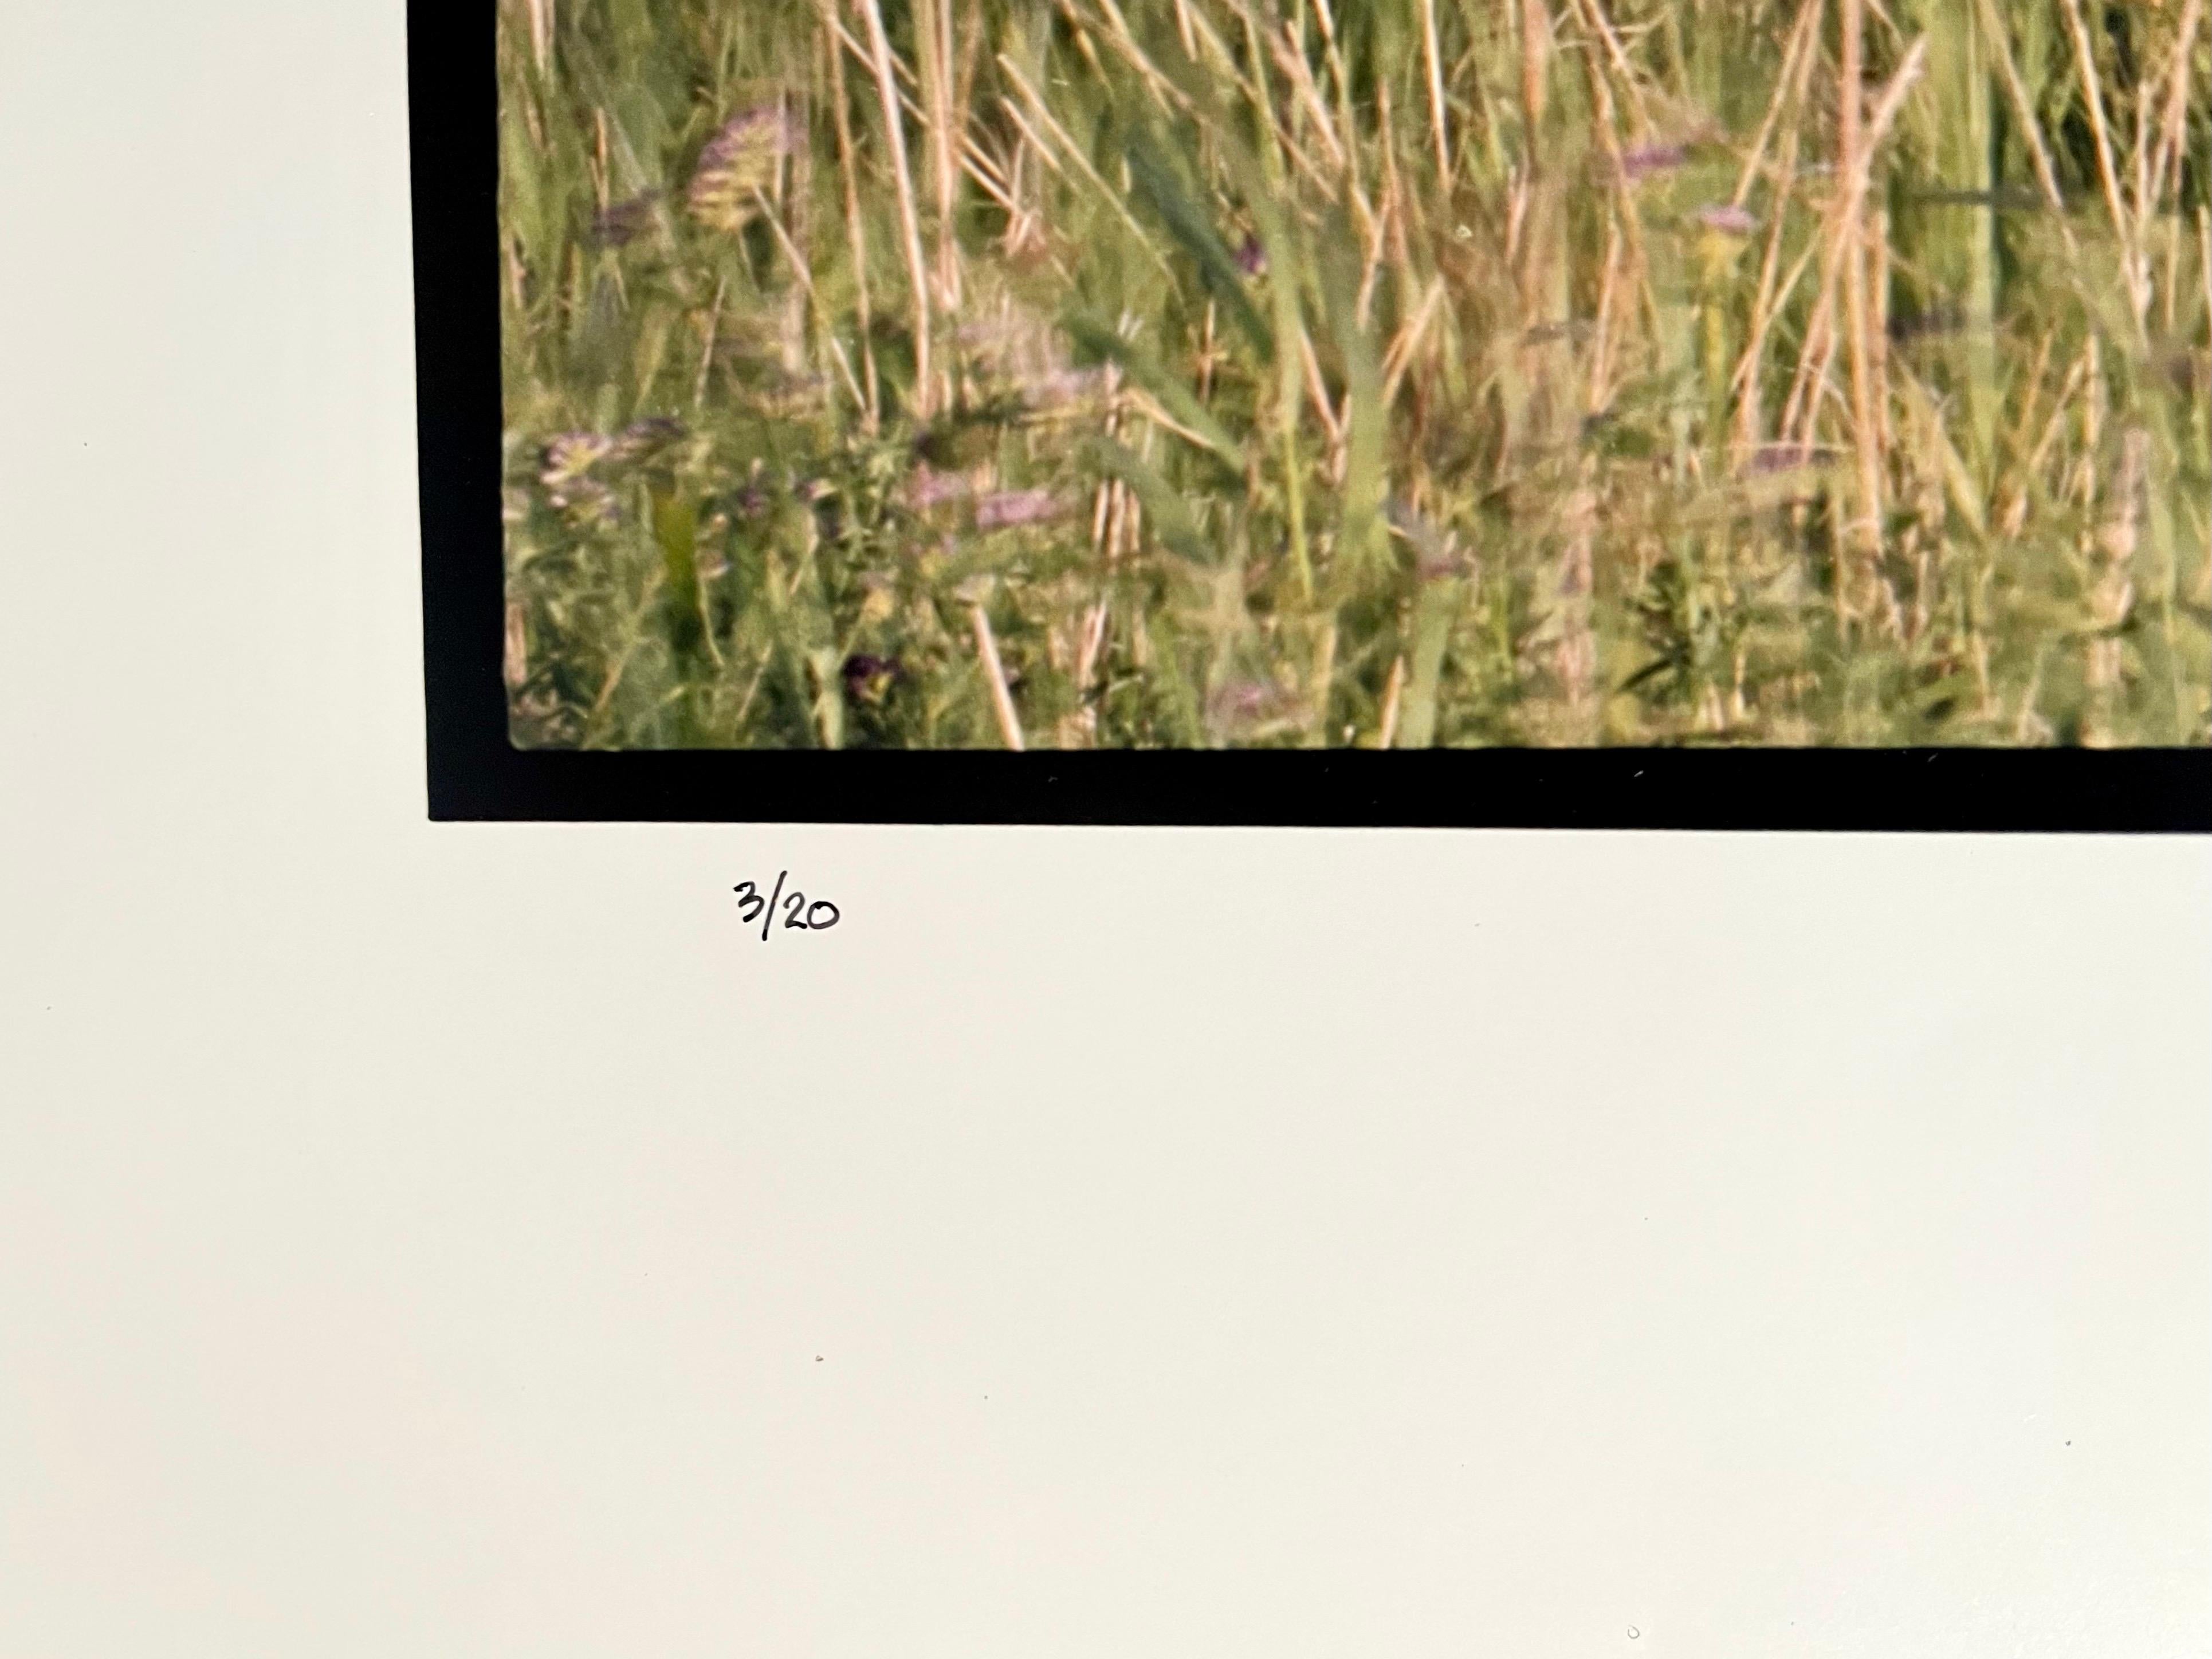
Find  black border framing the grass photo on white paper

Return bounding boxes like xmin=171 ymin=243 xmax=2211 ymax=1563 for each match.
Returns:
xmin=407 ymin=0 xmax=2212 ymax=834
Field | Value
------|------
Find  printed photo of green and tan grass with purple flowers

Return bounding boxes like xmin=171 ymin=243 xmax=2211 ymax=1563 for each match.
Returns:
xmin=498 ymin=0 xmax=2212 ymax=748
